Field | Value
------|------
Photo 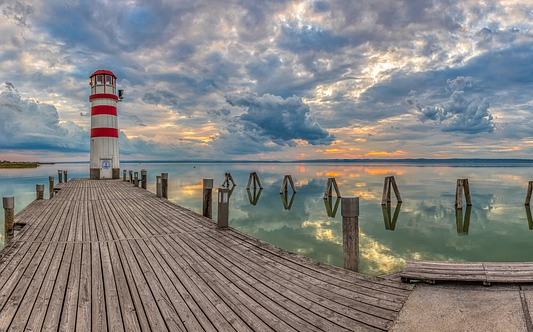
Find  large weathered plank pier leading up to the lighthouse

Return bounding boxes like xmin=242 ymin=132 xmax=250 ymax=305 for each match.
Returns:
xmin=0 ymin=179 xmax=413 ymax=331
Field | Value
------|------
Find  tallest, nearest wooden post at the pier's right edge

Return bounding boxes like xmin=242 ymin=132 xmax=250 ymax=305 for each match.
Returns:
xmin=341 ymin=197 xmax=359 ymax=271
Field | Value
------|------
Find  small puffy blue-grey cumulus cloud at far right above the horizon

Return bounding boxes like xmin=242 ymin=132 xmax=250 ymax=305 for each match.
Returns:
xmin=407 ymin=76 xmax=495 ymax=134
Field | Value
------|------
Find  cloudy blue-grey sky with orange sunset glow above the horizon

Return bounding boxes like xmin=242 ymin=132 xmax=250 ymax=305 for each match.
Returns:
xmin=0 ymin=0 xmax=533 ymax=161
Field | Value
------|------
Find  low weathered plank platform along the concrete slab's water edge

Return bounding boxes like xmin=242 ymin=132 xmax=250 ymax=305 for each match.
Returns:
xmin=400 ymin=261 xmax=533 ymax=286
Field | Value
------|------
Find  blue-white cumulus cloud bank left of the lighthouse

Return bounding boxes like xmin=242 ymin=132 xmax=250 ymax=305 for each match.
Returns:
xmin=0 ymin=82 xmax=89 ymax=152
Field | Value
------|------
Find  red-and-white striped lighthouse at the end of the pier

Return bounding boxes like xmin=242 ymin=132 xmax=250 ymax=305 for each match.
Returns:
xmin=89 ymin=70 xmax=122 ymax=180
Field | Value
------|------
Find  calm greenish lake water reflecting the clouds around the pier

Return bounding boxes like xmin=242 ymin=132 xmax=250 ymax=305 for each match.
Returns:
xmin=0 ymin=163 xmax=533 ymax=275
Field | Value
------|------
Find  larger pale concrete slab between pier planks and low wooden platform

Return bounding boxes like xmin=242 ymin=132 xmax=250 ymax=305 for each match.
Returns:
xmin=391 ymin=284 xmax=533 ymax=332
